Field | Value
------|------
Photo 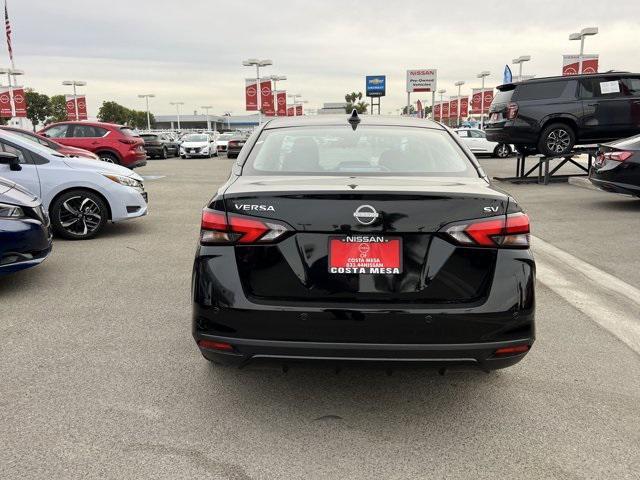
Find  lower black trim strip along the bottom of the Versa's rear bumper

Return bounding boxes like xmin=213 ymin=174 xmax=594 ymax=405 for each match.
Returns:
xmin=194 ymin=334 xmax=534 ymax=370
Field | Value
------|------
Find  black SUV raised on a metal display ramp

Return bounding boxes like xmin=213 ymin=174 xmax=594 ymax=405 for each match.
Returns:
xmin=485 ymin=72 xmax=640 ymax=155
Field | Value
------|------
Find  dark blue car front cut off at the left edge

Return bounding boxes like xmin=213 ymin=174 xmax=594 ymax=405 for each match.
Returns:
xmin=0 ymin=177 xmax=52 ymax=276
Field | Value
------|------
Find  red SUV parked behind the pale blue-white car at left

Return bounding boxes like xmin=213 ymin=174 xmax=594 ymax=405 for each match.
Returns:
xmin=38 ymin=122 xmax=147 ymax=168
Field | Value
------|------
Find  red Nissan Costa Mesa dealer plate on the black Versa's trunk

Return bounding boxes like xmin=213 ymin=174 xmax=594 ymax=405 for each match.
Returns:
xmin=329 ymin=235 xmax=402 ymax=275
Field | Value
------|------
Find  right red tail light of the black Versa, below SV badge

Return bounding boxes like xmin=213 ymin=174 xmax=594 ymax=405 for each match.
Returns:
xmin=445 ymin=212 xmax=530 ymax=248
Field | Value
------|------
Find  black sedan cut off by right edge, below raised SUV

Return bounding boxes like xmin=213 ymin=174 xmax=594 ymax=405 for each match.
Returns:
xmin=589 ymin=135 xmax=640 ymax=197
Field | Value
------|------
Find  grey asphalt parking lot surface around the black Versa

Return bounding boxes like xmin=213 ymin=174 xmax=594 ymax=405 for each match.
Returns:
xmin=0 ymin=158 xmax=640 ymax=479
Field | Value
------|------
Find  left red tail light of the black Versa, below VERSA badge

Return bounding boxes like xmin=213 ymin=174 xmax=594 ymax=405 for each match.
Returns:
xmin=200 ymin=209 xmax=289 ymax=245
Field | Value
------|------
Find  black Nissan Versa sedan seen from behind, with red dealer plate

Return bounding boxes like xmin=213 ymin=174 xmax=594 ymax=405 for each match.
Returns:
xmin=192 ymin=114 xmax=535 ymax=371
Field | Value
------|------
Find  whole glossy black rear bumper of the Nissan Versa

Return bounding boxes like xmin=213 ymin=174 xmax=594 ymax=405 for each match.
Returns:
xmin=192 ymin=247 xmax=535 ymax=369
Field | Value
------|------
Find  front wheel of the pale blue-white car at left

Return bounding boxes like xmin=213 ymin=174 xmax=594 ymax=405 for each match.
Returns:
xmin=50 ymin=189 xmax=109 ymax=240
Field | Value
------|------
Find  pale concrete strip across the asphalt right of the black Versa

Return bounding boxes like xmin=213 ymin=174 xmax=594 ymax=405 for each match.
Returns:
xmin=533 ymin=237 xmax=640 ymax=354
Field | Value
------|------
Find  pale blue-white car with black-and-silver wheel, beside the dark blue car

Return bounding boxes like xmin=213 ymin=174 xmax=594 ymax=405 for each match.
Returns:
xmin=0 ymin=132 xmax=147 ymax=239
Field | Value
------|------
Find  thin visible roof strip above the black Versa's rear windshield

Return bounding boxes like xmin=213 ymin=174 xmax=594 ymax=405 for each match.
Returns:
xmin=264 ymin=113 xmax=444 ymax=130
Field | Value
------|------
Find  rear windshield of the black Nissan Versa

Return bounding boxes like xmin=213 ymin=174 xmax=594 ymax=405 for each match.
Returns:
xmin=243 ymin=125 xmax=479 ymax=177
